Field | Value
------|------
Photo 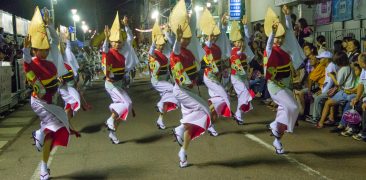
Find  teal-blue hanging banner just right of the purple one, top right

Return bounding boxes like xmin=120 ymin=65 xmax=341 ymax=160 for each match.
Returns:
xmin=332 ymin=0 xmax=353 ymax=22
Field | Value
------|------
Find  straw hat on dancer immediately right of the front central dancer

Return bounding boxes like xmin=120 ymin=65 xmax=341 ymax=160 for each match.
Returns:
xmin=199 ymin=8 xmax=221 ymax=36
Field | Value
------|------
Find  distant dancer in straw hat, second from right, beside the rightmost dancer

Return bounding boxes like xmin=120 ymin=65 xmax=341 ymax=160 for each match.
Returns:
xmin=229 ymin=17 xmax=254 ymax=125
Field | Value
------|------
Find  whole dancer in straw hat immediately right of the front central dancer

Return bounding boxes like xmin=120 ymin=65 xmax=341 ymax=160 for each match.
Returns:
xmin=199 ymin=9 xmax=231 ymax=136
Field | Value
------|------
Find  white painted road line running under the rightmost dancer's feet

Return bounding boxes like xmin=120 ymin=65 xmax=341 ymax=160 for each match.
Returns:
xmin=245 ymin=133 xmax=330 ymax=180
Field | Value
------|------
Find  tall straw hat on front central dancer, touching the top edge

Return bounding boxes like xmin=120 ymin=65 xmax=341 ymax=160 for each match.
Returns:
xmin=169 ymin=0 xmax=192 ymax=38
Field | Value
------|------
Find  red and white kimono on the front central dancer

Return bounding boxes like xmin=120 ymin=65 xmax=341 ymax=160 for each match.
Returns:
xmin=170 ymin=42 xmax=211 ymax=139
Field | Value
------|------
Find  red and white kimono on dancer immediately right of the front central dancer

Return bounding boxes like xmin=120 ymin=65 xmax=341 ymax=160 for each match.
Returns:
xmin=203 ymin=42 xmax=231 ymax=117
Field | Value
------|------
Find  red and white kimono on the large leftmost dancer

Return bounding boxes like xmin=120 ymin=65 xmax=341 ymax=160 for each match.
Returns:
xmin=23 ymin=48 xmax=70 ymax=147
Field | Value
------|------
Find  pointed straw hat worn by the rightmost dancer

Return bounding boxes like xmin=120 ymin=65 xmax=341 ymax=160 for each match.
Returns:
xmin=264 ymin=7 xmax=285 ymax=37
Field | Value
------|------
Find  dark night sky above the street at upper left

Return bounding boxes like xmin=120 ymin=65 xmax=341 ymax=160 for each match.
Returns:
xmin=0 ymin=0 xmax=144 ymax=32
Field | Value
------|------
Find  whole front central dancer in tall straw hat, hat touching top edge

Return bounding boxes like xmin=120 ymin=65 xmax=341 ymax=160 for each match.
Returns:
xmin=169 ymin=0 xmax=211 ymax=168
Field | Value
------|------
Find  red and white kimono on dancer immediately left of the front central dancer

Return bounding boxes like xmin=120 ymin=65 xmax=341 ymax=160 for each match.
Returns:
xmin=149 ymin=50 xmax=179 ymax=113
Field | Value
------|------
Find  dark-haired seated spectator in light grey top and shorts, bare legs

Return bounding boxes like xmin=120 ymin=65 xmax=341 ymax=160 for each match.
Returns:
xmin=316 ymin=52 xmax=355 ymax=128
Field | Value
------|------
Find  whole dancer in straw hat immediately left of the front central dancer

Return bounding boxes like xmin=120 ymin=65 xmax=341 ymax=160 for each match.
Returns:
xmin=149 ymin=21 xmax=178 ymax=129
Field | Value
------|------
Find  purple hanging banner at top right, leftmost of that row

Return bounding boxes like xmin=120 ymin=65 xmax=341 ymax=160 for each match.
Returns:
xmin=315 ymin=0 xmax=332 ymax=25
